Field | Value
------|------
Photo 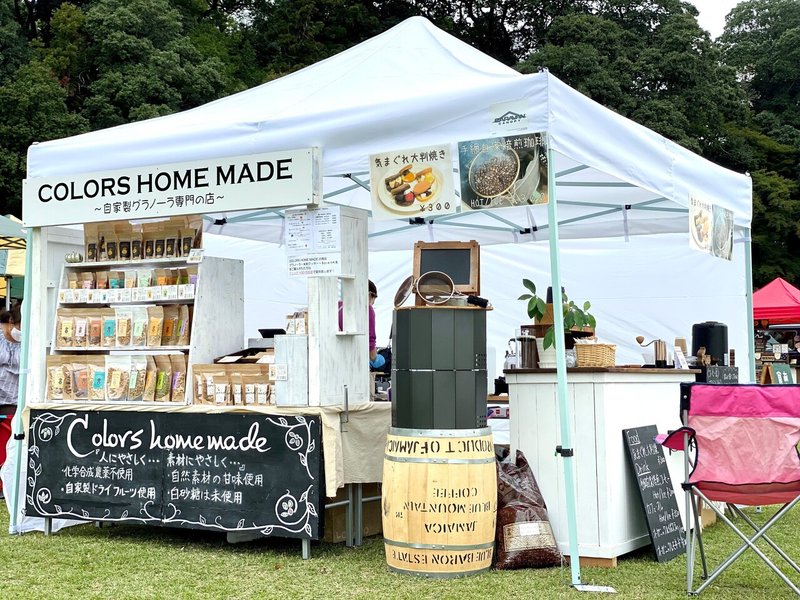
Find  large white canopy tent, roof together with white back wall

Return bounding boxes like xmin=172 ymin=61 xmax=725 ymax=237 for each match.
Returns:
xmin=23 ymin=17 xmax=752 ymax=583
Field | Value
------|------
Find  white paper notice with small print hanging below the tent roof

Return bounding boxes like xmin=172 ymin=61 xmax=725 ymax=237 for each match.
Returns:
xmin=286 ymin=206 xmax=342 ymax=277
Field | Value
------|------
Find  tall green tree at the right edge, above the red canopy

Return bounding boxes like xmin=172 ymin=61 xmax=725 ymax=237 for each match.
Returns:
xmin=719 ymin=0 xmax=800 ymax=286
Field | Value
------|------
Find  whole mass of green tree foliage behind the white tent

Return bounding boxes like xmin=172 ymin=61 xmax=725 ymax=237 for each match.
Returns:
xmin=0 ymin=0 xmax=800 ymax=285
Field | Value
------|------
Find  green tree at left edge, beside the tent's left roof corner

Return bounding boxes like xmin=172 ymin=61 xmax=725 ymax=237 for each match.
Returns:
xmin=0 ymin=61 xmax=88 ymax=216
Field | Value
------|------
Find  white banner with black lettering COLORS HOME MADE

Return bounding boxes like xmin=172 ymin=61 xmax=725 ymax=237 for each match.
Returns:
xmin=22 ymin=148 xmax=321 ymax=227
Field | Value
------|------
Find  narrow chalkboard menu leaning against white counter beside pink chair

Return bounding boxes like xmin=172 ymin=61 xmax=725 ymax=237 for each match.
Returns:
xmin=622 ymin=425 xmax=686 ymax=562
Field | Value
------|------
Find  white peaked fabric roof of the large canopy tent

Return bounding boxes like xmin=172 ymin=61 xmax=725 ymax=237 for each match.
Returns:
xmin=23 ymin=17 xmax=752 ymax=249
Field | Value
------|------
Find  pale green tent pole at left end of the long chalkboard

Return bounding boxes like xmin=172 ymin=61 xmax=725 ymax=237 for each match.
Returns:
xmin=8 ymin=227 xmax=35 ymax=533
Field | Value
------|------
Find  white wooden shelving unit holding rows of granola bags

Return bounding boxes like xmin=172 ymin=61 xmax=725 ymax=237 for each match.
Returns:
xmin=43 ymin=256 xmax=244 ymax=405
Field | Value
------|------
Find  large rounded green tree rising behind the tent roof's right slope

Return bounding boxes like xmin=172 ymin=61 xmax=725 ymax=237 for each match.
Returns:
xmin=518 ymin=0 xmax=747 ymax=155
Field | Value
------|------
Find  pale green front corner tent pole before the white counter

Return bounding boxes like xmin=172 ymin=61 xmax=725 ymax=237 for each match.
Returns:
xmin=547 ymin=141 xmax=581 ymax=586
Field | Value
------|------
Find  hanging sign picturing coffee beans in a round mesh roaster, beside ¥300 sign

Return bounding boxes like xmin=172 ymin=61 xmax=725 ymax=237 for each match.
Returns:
xmin=458 ymin=133 xmax=547 ymax=210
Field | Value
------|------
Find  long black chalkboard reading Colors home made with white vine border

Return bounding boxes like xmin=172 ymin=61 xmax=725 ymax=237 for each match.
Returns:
xmin=26 ymin=410 xmax=324 ymax=540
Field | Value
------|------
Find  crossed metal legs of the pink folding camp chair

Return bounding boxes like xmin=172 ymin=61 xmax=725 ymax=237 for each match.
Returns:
xmin=686 ymin=488 xmax=800 ymax=595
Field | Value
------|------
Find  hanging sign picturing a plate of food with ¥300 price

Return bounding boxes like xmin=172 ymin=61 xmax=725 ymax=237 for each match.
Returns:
xmin=369 ymin=145 xmax=458 ymax=220
